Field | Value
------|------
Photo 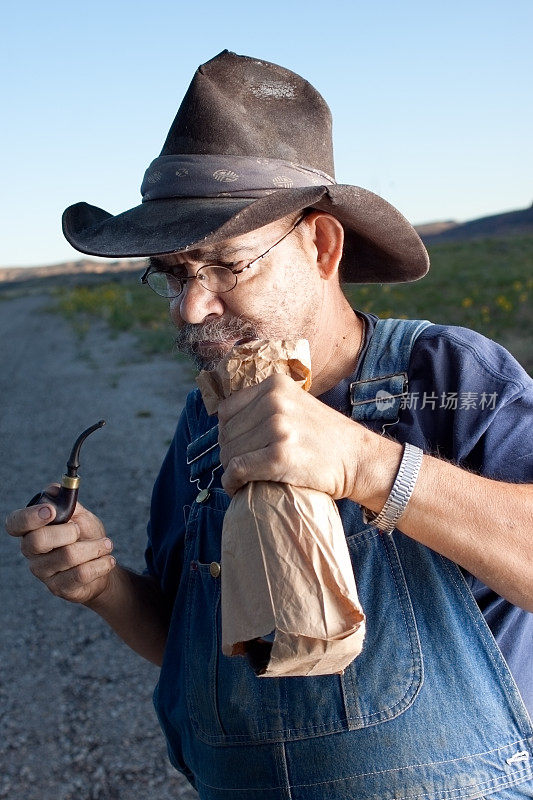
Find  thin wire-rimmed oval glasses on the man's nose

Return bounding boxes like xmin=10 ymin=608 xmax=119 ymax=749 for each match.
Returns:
xmin=141 ymin=214 xmax=305 ymax=300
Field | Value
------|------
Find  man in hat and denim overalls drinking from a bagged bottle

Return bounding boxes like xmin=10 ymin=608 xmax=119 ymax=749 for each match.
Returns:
xmin=7 ymin=52 xmax=533 ymax=800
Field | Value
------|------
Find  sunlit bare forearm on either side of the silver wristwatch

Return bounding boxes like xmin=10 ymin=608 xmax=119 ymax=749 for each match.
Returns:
xmin=352 ymin=434 xmax=533 ymax=611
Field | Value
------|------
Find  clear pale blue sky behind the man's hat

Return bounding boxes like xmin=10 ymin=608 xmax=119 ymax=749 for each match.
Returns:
xmin=0 ymin=0 xmax=533 ymax=266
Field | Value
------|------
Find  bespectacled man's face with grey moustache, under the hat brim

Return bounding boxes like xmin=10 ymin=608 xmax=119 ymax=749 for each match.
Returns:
xmin=154 ymin=216 xmax=322 ymax=369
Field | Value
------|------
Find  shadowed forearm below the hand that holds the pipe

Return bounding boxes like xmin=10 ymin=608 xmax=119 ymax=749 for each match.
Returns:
xmin=86 ymin=565 xmax=169 ymax=666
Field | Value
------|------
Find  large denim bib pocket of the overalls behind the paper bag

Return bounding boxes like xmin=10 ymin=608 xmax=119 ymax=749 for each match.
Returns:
xmin=185 ymin=490 xmax=422 ymax=744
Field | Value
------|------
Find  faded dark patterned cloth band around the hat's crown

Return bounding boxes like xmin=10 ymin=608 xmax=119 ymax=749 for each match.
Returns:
xmin=141 ymin=154 xmax=335 ymax=203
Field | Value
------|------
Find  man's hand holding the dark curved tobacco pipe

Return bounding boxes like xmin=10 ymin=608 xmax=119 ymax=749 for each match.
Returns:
xmin=6 ymin=486 xmax=115 ymax=603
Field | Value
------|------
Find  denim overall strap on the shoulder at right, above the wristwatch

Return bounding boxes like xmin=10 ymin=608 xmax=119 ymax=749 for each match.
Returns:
xmin=350 ymin=319 xmax=432 ymax=425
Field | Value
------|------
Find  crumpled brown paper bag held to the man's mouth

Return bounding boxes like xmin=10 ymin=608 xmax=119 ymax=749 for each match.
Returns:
xmin=197 ymin=339 xmax=365 ymax=677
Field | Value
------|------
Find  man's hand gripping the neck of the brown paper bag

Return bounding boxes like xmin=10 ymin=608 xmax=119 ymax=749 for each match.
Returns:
xmin=218 ymin=374 xmax=401 ymax=505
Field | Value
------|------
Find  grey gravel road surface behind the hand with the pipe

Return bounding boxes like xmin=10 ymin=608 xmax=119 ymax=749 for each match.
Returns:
xmin=0 ymin=288 xmax=197 ymax=800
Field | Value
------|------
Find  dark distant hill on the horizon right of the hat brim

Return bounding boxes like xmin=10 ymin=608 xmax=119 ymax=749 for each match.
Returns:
xmin=416 ymin=205 xmax=533 ymax=245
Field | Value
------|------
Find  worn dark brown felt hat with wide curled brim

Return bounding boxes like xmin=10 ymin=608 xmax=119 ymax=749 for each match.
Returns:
xmin=63 ymin=50 xmax=429 ymax=283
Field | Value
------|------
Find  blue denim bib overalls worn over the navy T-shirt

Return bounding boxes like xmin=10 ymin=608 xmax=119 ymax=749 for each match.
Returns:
xmin=154 ymin=320 xmax=533 ymax=800
